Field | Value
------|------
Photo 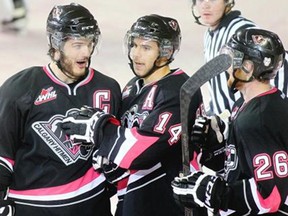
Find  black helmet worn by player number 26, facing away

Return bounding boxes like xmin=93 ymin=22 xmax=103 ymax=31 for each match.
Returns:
xmin=220 ymin=28 xmax=285 ymax=80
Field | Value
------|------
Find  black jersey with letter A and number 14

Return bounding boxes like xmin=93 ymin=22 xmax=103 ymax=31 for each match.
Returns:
xmin=98 ymin=69 xmax=202 ymax=216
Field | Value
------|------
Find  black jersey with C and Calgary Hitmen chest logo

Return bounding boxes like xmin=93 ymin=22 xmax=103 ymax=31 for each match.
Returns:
xmin=0 ymin=66 xmax=121 ymax=216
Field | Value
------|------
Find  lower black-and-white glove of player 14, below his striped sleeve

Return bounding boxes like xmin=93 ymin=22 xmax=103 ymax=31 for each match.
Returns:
xmin=92 ymin=150 xmax=130 ymax=184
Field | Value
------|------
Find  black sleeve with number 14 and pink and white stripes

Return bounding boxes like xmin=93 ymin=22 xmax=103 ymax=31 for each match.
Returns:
xmin=98 ymin=89 xmax=202 ymax=170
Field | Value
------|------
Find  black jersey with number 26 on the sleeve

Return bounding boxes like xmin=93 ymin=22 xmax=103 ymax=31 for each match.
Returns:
xmin=221 ymin=88 xmax=288 ymax=216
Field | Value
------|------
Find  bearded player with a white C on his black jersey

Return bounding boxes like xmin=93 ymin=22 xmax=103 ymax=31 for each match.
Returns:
xmin=0 ymin=4 xmax=121 ymax=216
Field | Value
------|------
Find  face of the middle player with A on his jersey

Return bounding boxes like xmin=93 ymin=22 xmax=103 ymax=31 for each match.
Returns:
xmin=130 ymin=38 xmax=159 ymax=77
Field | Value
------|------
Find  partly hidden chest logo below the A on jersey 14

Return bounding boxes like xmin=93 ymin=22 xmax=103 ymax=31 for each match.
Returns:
xmin=121 ymin=104 xmax=149 ymax=128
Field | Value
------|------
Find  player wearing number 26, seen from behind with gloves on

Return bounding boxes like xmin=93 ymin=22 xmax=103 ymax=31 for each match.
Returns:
xmin=172 ymin=29 xmax=288 ymax=216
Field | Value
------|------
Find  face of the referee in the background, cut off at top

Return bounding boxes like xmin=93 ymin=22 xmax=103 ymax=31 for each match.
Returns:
xmin=196 ymin=0 xmax=225 ymax=29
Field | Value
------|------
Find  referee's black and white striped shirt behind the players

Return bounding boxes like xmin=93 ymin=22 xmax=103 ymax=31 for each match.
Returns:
xmin=204 ymin=11 xmax=256 ymax=114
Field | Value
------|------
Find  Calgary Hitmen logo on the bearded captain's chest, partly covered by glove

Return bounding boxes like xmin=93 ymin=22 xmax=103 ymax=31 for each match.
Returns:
xmin=32 ymin=109 xmax=93 ymax=165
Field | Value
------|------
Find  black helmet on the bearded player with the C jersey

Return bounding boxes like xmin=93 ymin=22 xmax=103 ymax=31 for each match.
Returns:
xmin=46 ymin=3 xmax=101 ymax=50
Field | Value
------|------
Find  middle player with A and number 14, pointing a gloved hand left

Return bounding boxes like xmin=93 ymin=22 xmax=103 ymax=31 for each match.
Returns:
xmin=63 ymin=14 xmax=202 ymax=216
